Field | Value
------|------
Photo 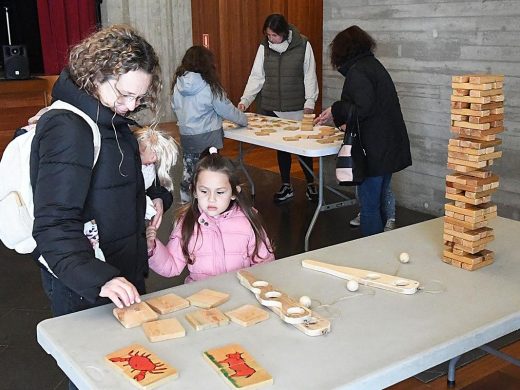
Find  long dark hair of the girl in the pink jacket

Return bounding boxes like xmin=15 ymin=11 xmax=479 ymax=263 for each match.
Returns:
xmin=177 ymin=152 xmax=273 ymax=264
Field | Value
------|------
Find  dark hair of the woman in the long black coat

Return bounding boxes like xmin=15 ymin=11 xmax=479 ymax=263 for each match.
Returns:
xmin=329 ymin=26 xmax=377 ymax=69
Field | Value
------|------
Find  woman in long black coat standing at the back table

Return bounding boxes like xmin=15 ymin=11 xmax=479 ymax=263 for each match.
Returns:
xmin=316 ymin=26 xmax=412 ymax=236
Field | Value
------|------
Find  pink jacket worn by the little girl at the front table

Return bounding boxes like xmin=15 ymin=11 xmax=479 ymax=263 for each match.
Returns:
xmin=149 ymin=206 xmax=274 ymax=283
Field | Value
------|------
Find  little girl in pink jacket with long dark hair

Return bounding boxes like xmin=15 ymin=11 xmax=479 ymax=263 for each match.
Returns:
xmin=146 ymin=147 xmax=274 ymax=283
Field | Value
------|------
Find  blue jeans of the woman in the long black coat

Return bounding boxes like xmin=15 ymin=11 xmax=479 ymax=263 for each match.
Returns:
xmin=358 ymin=174 xmax=392 ymax=236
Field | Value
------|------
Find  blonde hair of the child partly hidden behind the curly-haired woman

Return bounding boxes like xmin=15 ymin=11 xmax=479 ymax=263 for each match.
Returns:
xmin=133 ymin=126 xmax=179 ymax=192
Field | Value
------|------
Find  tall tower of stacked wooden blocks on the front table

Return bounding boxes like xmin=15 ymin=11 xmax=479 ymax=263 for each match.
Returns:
xmin=443 ymin=75 xmax=504 ymax=270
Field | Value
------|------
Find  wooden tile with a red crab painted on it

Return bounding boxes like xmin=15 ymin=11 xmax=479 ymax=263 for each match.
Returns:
xmin=105 ymin=344 xmax=179 ymax=389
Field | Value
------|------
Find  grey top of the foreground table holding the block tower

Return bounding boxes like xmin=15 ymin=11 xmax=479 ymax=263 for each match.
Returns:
xmin=37 ymin=217 xmax=520 ymax=389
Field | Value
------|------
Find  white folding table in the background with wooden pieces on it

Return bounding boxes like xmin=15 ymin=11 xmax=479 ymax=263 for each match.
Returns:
xmin=224 ymin=114 xmax=356 ymax=251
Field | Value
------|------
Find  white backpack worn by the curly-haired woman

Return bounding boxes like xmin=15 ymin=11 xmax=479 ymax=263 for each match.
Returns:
xmin=0 ymin=100 xmax=101 ymax=253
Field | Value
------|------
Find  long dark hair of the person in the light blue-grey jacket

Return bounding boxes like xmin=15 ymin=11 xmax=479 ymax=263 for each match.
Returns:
xmin=172 ymin=46 xmax=224 ymax=98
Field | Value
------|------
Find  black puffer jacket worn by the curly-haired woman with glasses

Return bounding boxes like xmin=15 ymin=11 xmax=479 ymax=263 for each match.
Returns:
xmin=30 ymin=71 xmax=172 ymax=303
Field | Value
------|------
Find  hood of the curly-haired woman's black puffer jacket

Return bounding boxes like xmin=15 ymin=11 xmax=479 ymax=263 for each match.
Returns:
xmin=52 ymin=69 xmax=136 ymax=128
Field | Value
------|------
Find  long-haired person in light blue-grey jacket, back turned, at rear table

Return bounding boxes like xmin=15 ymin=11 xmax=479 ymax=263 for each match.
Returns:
xmin=171 ymin=46 xmax=247 ymax=202
